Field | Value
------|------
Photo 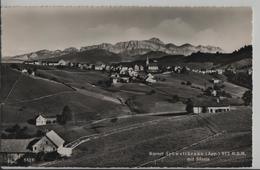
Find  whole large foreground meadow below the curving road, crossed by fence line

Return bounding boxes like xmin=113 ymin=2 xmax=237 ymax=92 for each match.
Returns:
xmin=49 ymin=108 xmax=252 ymax=167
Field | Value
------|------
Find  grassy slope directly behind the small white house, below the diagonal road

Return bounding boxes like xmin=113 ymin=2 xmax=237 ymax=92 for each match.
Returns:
xmin=3 ymin=92 xmax=131 ymax=122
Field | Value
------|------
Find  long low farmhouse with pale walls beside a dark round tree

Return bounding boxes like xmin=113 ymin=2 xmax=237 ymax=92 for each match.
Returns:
xmin=193 ymin=100 xmax=230 ymax=113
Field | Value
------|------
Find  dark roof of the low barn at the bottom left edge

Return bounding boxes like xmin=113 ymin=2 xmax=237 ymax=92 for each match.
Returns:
xmin=0 ymin=138 xmax=35 ymax=153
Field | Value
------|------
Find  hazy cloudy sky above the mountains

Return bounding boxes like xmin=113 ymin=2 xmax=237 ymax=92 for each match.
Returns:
xmin=1 ymin=7 xmax=252 ymax=56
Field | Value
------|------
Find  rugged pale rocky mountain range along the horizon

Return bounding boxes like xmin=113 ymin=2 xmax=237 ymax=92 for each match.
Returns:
xmin=4 ymin=37 xmax=223 ymax=62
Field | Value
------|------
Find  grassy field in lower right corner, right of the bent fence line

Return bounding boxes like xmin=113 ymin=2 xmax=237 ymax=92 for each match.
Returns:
xmin=154 ymin=108 xmax=252 ymax=167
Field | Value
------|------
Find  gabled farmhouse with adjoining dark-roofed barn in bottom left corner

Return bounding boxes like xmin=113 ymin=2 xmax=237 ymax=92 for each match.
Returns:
xmin=0 ymin=130 xmax=72 ymax=165
